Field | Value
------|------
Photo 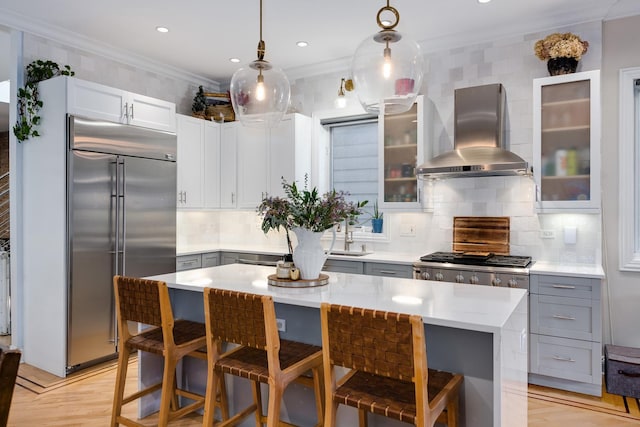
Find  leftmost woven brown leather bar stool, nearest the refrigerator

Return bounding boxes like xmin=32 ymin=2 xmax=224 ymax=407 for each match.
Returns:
xmin=111 ymin=276 xmax=228 ymax=427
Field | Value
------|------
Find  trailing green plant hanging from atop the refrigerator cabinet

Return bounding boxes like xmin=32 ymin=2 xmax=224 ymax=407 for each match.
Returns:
xmin=13 ymin=59 xmax=75 ymax=142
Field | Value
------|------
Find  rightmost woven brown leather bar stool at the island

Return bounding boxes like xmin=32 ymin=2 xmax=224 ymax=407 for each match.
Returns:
xmin=320 ymin=303 xmax=463 ymax=427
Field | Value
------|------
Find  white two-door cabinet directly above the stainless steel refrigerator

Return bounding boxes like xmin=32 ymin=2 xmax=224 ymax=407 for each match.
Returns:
xmin=65 ymin=77 xmax=176 ymax=132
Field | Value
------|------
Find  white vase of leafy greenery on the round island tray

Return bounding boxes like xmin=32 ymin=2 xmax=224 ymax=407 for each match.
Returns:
xmin=257 ymin=176 xmax=367 ymax=280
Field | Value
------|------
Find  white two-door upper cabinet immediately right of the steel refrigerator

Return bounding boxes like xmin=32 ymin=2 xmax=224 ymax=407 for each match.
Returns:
xmin=176 ymin=114 xmax=220 ymax=208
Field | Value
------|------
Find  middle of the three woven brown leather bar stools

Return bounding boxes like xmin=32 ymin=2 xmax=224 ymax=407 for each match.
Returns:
xmin=203 ymin=288 xmax=323 ymax=427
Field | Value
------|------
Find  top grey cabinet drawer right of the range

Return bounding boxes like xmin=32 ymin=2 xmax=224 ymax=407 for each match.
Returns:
xmin=530 ymin=274 xmax=600 ymax=300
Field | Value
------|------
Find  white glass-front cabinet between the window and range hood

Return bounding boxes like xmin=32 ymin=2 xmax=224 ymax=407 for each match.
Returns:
xmin=378 ymin=95 xmax=430 ymax=210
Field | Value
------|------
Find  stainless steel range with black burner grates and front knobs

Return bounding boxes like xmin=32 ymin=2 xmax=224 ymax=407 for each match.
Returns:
xmin=413 ymin=252 xmax=532 ymax=289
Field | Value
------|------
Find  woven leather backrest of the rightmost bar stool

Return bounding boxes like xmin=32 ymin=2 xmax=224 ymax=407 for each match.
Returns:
xmin=321 ymin=303 xmax=427 ymax=382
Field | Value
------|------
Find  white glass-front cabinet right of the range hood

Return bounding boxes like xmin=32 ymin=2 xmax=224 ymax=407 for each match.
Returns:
xmin=533 ymin=70 xmax=600 ymax=212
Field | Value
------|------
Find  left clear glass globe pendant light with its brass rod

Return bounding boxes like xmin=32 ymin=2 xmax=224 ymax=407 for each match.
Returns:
xmin=229 ymin=0 xmax=291 ymax=127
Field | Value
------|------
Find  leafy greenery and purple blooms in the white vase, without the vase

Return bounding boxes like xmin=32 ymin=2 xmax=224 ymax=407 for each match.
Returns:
xmin=257 ymin=176 xmax=367 ymax=252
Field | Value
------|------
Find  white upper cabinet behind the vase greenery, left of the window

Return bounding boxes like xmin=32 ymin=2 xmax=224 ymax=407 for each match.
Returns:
xmin=237 ymin=114 xmax=311 ymax=209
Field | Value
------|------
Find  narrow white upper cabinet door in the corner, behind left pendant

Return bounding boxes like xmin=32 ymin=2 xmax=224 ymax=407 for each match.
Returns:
xmin=220 ymin=122 xmax=242 ymax=208
